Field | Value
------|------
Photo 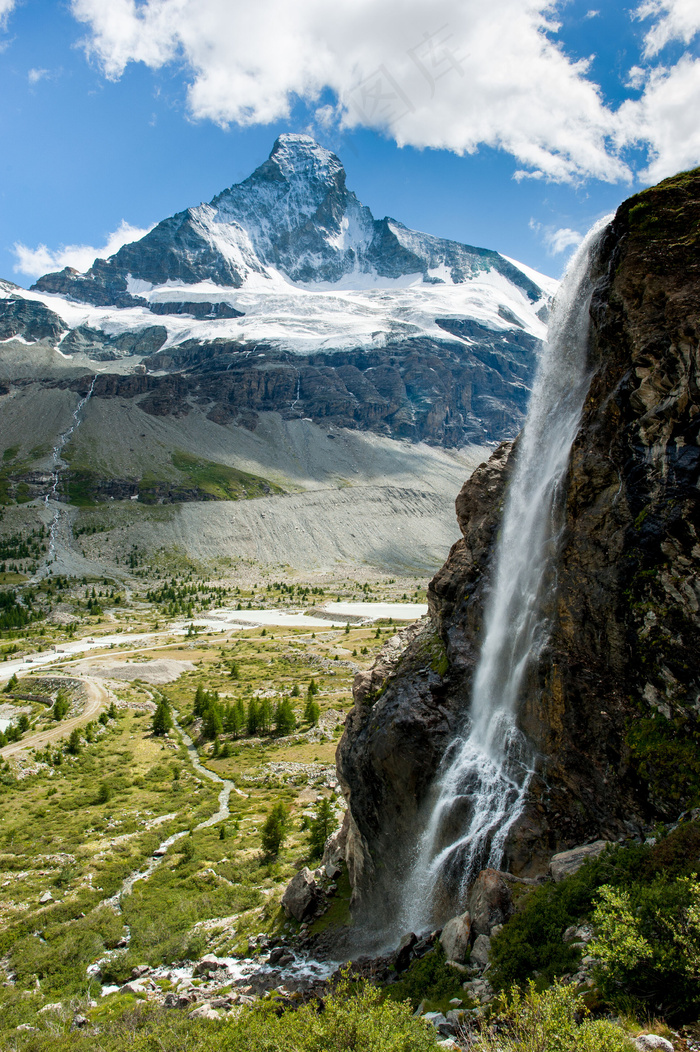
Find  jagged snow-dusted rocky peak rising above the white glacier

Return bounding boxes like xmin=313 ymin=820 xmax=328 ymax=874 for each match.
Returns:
xmin=33 ymin=135 xmax=542 ymax=306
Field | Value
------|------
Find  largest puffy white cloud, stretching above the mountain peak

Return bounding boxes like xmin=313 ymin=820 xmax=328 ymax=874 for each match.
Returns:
xmin=68 ymin=0 xmax=700 ymax=181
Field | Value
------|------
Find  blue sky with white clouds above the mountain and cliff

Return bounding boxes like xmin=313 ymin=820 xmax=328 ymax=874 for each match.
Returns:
xmin=0 ymin=0 xmax=700 ymax=285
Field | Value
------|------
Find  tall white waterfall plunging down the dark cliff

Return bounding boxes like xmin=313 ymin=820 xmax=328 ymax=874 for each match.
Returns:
xmin=400 ymin=217 xmax=609 ymax=931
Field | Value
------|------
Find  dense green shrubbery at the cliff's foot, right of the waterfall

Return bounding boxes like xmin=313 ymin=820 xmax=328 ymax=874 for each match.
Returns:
xmin=489 ymin=822 xmax=700 ymax=1019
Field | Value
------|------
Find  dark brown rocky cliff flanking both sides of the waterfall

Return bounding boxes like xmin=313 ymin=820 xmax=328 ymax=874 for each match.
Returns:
xmin=338 ymin=164 xmax=700 ymax=910
